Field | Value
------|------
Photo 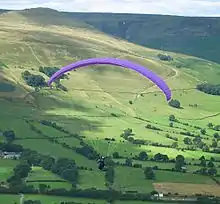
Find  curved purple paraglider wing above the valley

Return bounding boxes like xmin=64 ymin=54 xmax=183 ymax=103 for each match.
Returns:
xmin=48 ymin=58 xmax=171 ymax=101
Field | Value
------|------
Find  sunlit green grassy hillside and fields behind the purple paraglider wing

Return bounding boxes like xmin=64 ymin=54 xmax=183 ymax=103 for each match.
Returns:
xmin=0 ymin=9 xmax=220 ymax=204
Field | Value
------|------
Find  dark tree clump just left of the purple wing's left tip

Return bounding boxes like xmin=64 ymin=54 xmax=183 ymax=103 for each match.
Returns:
xmin=22 ymin=71 xmax=47 ymax=88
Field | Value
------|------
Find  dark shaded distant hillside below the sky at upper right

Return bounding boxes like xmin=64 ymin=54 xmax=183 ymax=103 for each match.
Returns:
xmin=68 ymin=13 xmax=220 ymax=63
